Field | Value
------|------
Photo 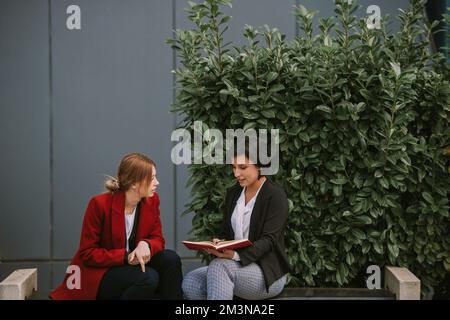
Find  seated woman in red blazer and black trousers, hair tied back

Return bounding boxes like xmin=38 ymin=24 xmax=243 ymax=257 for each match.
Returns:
xmin=50 ymin=153 xmax=182 ymax=299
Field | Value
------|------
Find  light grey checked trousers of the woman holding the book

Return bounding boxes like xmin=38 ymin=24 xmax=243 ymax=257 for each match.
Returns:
xmin=183 ymin=258 xmax=286 ymax=300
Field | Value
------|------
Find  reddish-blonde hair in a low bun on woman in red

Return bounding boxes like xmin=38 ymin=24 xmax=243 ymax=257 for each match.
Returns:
xmin=105 ymin=153 xmax=156 ymax=193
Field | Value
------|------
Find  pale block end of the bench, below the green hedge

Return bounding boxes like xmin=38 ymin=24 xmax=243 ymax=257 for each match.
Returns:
xmin=384 ymin=267 xmax=420 ymax=300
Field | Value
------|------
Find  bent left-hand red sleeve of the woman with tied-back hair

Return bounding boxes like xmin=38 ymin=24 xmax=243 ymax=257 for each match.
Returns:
xmin=79 ymin=198 xmax=126 ymax=267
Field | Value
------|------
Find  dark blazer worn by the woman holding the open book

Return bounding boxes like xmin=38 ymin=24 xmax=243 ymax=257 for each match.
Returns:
xmin=221 ymin=179 xmax=290 ymax=290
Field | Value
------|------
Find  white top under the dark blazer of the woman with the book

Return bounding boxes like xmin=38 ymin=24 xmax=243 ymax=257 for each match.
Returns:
xmin=231 ymin=179 xmax=266 ymax=261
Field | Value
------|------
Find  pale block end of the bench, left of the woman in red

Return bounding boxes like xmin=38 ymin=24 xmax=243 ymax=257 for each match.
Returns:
xmin=0 ymin=269 xmax=37 ymax=300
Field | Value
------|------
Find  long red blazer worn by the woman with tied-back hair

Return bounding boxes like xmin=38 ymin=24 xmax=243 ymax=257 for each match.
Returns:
xmin=50 ymin=192 xmax=164 ymax=300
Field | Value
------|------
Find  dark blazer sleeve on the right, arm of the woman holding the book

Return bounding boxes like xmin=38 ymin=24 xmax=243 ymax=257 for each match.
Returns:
xmin=237 ymin=190 xmax=288 ymax=266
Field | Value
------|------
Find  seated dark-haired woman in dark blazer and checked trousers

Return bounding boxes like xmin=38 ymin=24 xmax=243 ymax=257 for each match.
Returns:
xmin=183 ymin=149 xmax=290 ymax=300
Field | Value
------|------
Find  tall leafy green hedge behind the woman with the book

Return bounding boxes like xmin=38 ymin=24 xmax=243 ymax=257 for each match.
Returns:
xmin=168 ymin=0 xmax=450 ymax=296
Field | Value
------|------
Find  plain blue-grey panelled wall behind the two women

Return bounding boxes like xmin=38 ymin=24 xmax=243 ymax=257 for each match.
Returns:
xmin=0 ymin=0 xmax=408 ymax=292
